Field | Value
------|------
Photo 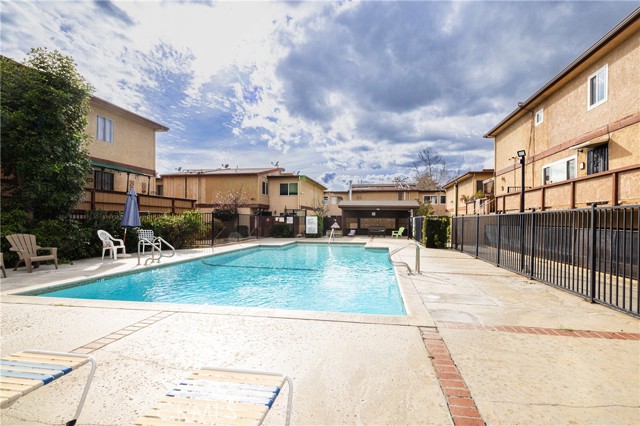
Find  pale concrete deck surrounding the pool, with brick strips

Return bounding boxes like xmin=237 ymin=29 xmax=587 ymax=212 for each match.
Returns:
xmin=0 ymin=237 xmax=640 ymax=425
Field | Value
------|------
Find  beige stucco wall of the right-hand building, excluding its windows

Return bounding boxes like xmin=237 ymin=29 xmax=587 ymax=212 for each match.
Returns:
xmin=488 ymin=19 xmax=640 ymax=209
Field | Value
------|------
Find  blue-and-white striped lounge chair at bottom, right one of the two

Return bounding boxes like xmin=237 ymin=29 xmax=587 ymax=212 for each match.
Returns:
xmin=135 ymin=367 xmax=293 ymax=426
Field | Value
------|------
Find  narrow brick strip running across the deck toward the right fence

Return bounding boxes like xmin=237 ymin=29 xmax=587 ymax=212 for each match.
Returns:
xmin=436 ymin=322 xmax=640 ymax=340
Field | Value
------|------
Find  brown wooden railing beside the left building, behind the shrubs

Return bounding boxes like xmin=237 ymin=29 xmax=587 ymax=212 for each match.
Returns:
xmin=76 ymin=188 xmax=196 ymax=213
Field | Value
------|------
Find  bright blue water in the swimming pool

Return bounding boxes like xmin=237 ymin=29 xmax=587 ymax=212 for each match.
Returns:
xmin=38 ymin=244 xmax=405 ymax=315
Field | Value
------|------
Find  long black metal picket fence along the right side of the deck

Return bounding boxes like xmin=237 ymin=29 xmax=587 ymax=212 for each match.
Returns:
xmin=451 ymin=205 xmax=640 ymax=317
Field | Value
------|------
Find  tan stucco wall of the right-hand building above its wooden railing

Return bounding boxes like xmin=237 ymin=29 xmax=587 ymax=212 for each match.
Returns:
xmin=495 ymin=28 xmax=640 ymax=201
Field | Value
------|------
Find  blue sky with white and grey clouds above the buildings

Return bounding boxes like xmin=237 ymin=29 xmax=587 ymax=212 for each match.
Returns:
xmin=0 ymin=0 xmax=640 ymax=189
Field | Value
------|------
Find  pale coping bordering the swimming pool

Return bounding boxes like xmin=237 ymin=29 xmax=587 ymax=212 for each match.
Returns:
xmin=0 ymin=239 xmax=435 ymax=327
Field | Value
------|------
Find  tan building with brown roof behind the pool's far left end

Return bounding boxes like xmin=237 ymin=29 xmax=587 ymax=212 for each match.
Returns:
xmin=158 ymin=166 xmax=326 ymax=216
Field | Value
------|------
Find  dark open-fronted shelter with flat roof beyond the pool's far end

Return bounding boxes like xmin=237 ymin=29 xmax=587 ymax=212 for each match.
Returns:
xmin=338 ymin=200 xmax=419 ymax=235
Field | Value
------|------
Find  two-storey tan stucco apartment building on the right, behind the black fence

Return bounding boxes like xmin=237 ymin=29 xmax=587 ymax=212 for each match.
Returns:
xmin=485 ymin=8 xmax=640 ymax=212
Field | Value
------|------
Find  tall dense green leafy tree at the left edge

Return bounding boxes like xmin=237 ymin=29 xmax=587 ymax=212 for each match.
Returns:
xmin=0 ymin=48 xmax=93 ymax=221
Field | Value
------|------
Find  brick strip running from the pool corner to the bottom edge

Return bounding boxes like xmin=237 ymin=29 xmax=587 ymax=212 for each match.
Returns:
xmin=419 ymin=327 xmax=485 ymax=426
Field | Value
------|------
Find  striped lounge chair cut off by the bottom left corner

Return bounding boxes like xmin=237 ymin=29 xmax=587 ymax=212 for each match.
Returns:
xmin=0 ymin=350 xmax=96 ymax=426
